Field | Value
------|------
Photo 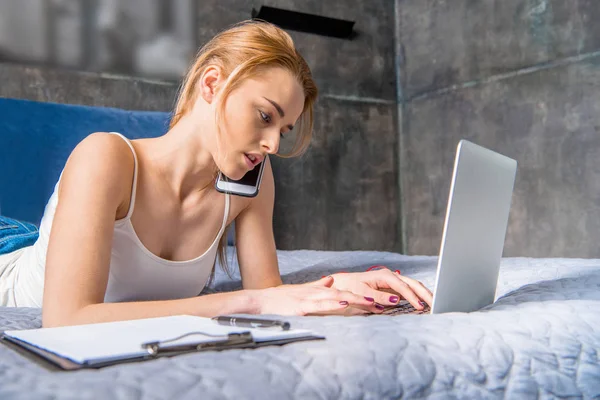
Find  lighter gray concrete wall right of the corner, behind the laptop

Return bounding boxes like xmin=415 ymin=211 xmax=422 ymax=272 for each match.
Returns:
xmin=395 ymin=0 xmax=600 ymax=257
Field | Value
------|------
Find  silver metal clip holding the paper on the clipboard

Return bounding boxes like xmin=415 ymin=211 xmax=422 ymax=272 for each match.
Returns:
xmin=142 ymin=331 xmax=255 ymax=357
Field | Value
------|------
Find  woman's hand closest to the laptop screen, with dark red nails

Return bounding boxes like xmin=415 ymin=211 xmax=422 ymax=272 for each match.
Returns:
xmin=331 ymin=266 xmax=433 ymax=313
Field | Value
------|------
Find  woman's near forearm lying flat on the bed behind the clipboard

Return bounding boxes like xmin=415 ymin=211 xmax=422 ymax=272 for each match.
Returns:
xmin=43 ymin=290 xmax=260 ymax=327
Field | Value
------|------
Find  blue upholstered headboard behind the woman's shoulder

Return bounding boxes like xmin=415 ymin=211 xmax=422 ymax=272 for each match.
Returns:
xmin=0 ymin=98 xmax=170 ymax=224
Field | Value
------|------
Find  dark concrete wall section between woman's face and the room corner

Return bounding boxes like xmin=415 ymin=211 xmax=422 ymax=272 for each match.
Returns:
xmin=197 ymin=0 xmax=401 ymax=250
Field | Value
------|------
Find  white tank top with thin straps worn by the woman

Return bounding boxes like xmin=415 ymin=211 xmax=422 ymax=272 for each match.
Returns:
xmin=14 ymin=132 xmax=229 ymax=307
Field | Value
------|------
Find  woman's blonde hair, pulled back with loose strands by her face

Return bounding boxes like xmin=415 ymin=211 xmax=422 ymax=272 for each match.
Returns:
xmin=171 ymin=20 xmax=318 ymax=280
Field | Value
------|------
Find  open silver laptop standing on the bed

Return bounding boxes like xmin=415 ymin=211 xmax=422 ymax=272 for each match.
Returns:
xmin=383 ymin=140 xmax=517 ymax=315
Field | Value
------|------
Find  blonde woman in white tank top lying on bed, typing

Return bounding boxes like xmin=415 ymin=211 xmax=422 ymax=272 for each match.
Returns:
xmin=0 ymin=21 xmax=431 ymax=327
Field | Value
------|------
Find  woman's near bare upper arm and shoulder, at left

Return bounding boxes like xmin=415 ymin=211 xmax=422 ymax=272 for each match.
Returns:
xmin=42 ymin=133 xmax=133 ymax=325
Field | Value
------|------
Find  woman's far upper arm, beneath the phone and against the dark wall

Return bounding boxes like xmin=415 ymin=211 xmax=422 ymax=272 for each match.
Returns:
xmin=235 ymin=159 xmax=281 ymax=289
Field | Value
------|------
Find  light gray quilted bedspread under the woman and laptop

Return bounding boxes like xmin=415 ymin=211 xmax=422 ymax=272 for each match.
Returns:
xmin=0 ymin=251 xmax=600 ymax=399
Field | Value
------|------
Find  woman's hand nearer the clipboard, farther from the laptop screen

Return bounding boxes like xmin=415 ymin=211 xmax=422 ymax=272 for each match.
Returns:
xmin=257 ymin=276 xmax=373 ymax=315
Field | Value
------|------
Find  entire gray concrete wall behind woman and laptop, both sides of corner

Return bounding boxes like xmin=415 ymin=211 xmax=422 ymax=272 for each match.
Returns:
xmin=0 ymin=0 xmax=600 ymax=257
